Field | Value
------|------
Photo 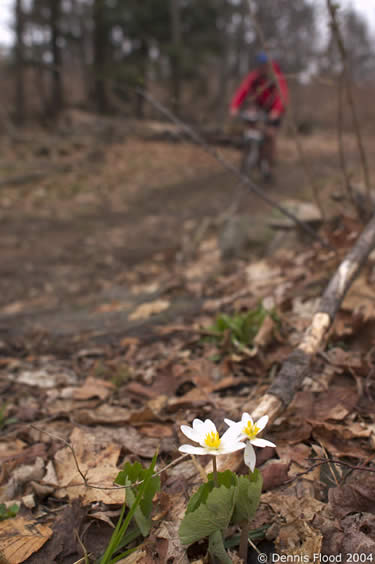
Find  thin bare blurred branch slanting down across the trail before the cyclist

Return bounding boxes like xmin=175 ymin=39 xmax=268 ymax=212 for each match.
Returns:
xmin=136 ymin=88 xmax=334 ymax=250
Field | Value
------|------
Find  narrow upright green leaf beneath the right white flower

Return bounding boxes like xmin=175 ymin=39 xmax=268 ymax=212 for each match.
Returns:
xmin=232 ymin=469 xmax=263 ymax=524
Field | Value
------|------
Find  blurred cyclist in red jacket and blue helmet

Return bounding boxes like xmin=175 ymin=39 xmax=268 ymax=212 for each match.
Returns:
xmin=230 ymin=52 xmax=288 ymax=178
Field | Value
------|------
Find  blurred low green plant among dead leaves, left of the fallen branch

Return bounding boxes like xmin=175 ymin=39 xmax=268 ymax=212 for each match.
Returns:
xmin=208 ymin=304 xmax=279 ymax=350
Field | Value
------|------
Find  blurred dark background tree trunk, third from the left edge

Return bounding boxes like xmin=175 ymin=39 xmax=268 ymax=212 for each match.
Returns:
xmin=93 ymin=0 xmax=109 ymax=114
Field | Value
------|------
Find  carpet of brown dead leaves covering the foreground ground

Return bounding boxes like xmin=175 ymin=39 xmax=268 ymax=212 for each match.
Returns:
xmin=0 ymin=145 xmax=375 ymax=563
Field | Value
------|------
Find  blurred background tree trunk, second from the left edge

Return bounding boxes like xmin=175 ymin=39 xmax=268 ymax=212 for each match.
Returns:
xmin=50 ymin=0 xmax=63 ymax=117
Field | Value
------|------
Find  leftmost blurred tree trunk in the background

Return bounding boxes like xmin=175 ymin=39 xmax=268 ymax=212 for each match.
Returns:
xmin=15 ymin=0 xmax=26 ymax=125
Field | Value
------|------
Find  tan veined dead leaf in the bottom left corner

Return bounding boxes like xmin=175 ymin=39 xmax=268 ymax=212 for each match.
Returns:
xmin=0 ymin=516 xmax=52 ymax=564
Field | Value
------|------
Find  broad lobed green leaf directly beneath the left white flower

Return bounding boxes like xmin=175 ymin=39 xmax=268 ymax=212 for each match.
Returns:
xmin=178 ymin=480 xmax=238 ymax=544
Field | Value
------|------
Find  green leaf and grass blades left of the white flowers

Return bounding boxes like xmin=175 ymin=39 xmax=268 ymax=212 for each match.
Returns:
xmin=99 ymin=453 xmax=160 ymax=564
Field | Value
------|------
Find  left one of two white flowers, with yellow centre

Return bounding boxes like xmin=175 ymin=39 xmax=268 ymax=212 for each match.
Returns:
xmin=178 ymin=419 xmax=245 ymax=456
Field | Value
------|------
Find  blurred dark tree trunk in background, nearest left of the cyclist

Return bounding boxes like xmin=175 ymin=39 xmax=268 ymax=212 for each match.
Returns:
xmin=169 ymin=0 xmax=182 ymax=113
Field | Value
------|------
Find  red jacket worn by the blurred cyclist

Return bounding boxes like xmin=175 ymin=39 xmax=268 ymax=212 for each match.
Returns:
xmin=230 ymin=61 xmax=288 ymax=116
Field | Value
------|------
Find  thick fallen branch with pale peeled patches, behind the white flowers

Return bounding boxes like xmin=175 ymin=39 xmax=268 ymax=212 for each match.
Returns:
xmin=219 ymin=210 xmax=375 ymax=470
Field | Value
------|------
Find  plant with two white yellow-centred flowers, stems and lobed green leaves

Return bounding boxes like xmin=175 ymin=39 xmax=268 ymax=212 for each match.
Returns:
xmin=179 ymin=413 xmax=275 ymax=564
